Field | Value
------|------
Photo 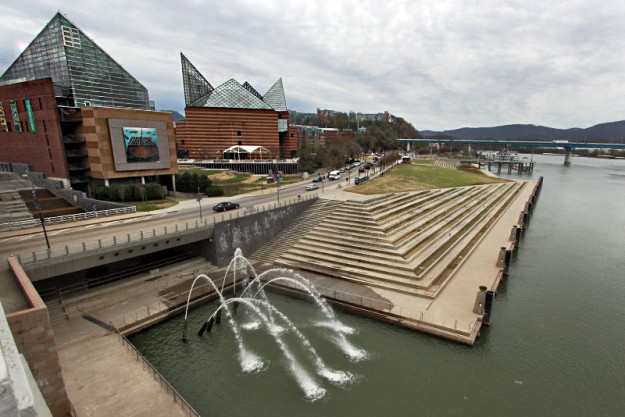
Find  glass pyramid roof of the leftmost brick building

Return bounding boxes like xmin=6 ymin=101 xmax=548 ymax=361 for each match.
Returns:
xmin=0 ymin=13 xmax=151 ymax=110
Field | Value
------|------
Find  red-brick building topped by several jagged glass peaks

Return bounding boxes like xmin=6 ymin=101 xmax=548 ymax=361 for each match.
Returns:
xmin=175 ymin=54 xmax=297 ymax=160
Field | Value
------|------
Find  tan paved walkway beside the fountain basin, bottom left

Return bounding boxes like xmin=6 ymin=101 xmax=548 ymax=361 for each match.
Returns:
xmin=54 ymin=318 xmax=193 ymax=417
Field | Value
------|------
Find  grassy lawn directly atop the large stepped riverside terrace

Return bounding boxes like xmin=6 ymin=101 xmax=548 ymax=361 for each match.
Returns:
xmin=348 ymin=161 xmax=508 ymax=195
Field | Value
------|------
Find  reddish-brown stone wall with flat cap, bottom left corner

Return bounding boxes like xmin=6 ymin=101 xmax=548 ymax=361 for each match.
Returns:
xmin=7 ymin=257 xmax=70 ymax=416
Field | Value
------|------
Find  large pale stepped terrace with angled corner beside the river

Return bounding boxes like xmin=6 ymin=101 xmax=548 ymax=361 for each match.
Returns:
xmin=275 ymin=183 xmax=525 ymax=298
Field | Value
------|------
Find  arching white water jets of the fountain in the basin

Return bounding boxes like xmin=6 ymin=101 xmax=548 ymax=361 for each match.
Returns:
xmin=182 ymin=249 xmax=367 ymax=401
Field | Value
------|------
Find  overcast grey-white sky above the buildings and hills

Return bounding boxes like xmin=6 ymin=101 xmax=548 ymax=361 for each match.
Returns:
xmin=0 ymin=0 xmax=625 ymax=130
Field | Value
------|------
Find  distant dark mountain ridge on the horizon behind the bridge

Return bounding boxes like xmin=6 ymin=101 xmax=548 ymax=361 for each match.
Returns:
xmin=421 ymin=120 xmax=625 ymax=143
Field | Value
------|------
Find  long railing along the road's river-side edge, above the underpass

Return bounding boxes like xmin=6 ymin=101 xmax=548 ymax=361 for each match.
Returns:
xmin=17 ymin=194 xmax=317 ymax=265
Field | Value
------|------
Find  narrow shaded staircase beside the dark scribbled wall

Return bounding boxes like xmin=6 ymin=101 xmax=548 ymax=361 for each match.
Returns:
xmin=248 ymin=198 xmax=342 ymax=264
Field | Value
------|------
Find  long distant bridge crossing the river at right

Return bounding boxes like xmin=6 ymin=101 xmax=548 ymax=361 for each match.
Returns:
xmin=399 ymin=139 xmax=625 ymax=166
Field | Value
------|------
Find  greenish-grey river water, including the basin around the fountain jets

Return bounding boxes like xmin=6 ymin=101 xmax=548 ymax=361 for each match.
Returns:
xmin=131 ymin=155 xmax=625 ymax=417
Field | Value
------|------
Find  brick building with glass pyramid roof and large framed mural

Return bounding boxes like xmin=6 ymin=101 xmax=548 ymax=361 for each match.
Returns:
xmin=0 ymin=13 xmax=177 ymax=192
